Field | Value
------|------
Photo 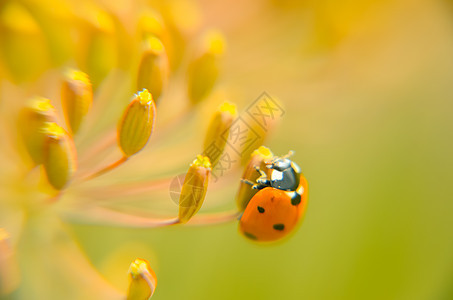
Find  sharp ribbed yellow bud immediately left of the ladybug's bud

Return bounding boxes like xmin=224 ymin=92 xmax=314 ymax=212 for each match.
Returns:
xmin=179 ymin=155 xmax=211 ymax=223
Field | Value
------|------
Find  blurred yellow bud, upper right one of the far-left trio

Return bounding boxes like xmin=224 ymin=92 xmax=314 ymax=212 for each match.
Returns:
xmin=61 ymin=69 xmax=93 ymax=135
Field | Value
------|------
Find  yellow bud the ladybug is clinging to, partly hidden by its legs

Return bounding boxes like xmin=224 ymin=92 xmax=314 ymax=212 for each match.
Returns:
xmin=236 ymin=146 xmax=274 ymax=211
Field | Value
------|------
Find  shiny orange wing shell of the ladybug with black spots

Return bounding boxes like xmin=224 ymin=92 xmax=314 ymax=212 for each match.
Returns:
xmin=239 ymin=176 xmax=308 ymax=242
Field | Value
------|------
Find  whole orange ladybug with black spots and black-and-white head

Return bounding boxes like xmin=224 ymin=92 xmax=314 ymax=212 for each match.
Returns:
xmin=239 ymin=151 xmax=308 ymax=242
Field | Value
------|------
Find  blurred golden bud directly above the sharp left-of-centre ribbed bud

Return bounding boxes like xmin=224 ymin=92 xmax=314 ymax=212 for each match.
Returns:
xmin=137 ymin=37 xmax=168 ymax=103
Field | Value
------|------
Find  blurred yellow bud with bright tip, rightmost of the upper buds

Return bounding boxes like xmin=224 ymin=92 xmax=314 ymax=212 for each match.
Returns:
xmin=187 ymin=32 xmax=224 ymax=104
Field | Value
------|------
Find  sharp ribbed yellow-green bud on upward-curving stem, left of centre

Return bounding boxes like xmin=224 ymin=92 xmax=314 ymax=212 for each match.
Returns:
xmin=118 ymin=89 xmax=156 ymax=157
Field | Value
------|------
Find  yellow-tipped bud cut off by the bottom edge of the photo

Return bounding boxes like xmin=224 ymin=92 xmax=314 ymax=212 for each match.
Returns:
xmin=127 ymin=258 xmax=157 ymax=300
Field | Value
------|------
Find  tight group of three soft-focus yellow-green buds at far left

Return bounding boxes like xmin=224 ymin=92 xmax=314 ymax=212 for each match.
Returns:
xmin=18 ymin=70 xmax=89 ymax=191
